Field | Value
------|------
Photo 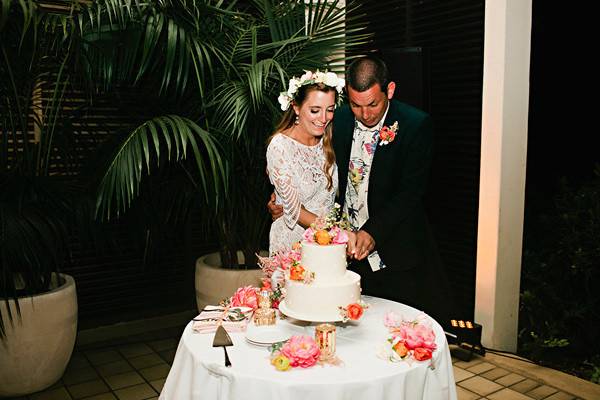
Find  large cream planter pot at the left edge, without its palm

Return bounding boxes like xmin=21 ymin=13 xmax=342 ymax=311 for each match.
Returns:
xmin=0 ymin=274 xmax=77 ymax=397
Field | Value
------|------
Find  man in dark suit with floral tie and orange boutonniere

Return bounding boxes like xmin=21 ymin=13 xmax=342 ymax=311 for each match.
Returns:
xmin=269 ymin=56 xmax=452 ymax=326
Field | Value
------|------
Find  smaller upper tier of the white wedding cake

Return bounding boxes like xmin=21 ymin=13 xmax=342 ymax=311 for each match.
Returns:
xmin=300 ymin=242 xmax=347 ymax=283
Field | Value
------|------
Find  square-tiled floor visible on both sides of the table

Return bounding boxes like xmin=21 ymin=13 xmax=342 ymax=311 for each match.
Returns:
xmin=9 ymin=328 xmax=600 ymax=400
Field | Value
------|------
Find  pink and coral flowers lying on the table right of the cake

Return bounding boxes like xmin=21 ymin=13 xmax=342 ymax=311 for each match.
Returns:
xmin=378 ymin=311 xmax=437 ymax=362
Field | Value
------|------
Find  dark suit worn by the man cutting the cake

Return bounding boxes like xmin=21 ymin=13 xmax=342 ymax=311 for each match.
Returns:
xmin=333 ymin=100 xmax=450 ymax=324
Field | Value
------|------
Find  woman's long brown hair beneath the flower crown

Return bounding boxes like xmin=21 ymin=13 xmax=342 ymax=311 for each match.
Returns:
xmin=267 ymin=83 xmax=338 ymax=190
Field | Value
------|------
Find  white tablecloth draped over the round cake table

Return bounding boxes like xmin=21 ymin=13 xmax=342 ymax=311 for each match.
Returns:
xmin=160 ymin=296 xmax=456 ymax=400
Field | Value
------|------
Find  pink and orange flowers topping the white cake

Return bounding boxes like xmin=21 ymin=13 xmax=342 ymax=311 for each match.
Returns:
xmin=302 ymin=203 xmax=350 ymax=246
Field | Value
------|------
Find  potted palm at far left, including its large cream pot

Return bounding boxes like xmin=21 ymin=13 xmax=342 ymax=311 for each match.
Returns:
xmin=0 ymin=0 xmax=235 ymax=397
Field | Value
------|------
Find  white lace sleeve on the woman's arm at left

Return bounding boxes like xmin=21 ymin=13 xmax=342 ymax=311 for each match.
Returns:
xmin=267 ymin=135 xmax=301 ymax=229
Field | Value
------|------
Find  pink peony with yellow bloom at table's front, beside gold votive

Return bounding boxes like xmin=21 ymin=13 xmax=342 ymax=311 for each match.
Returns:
xmin=271 ymin=335 xmax=321 ymax=371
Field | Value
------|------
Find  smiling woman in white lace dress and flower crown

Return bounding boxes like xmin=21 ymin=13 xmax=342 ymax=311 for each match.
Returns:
xmin=267 ymin=71 xmax=344 ymax=255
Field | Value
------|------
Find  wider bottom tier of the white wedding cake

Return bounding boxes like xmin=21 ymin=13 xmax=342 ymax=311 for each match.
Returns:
xmin=279 ymin=271 xmax=360 ymax=322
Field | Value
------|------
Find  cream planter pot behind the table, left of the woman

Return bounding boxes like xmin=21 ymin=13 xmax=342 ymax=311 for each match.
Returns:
xmin=195 ymin=252 xmax=263 ymax=311
